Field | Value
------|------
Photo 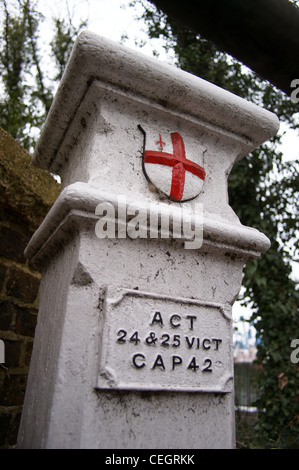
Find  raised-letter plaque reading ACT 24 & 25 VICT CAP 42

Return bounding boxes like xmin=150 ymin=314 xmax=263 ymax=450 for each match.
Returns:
xmin=97 ymin=287 xmax=233 ymax=393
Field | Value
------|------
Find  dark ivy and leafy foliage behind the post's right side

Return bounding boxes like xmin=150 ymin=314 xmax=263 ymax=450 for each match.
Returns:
xmin=133 ymin=0 xmax=299 ymax=447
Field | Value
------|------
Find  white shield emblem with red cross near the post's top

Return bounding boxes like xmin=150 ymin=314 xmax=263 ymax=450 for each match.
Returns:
xmin=138 ymin=126 xmax=206 ymax=202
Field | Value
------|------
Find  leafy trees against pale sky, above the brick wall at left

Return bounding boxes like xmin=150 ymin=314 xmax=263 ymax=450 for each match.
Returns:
xmin=0 ymin=0 xmax=86 ymax=149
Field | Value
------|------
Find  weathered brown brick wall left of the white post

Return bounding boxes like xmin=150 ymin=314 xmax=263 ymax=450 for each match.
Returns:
xmin=0 ymin=128 xmax=60 ymax=448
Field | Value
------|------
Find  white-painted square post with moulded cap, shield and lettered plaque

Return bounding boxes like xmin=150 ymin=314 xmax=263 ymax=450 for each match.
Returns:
xmin=18 ymin=32 xmax=279 ymax=449
